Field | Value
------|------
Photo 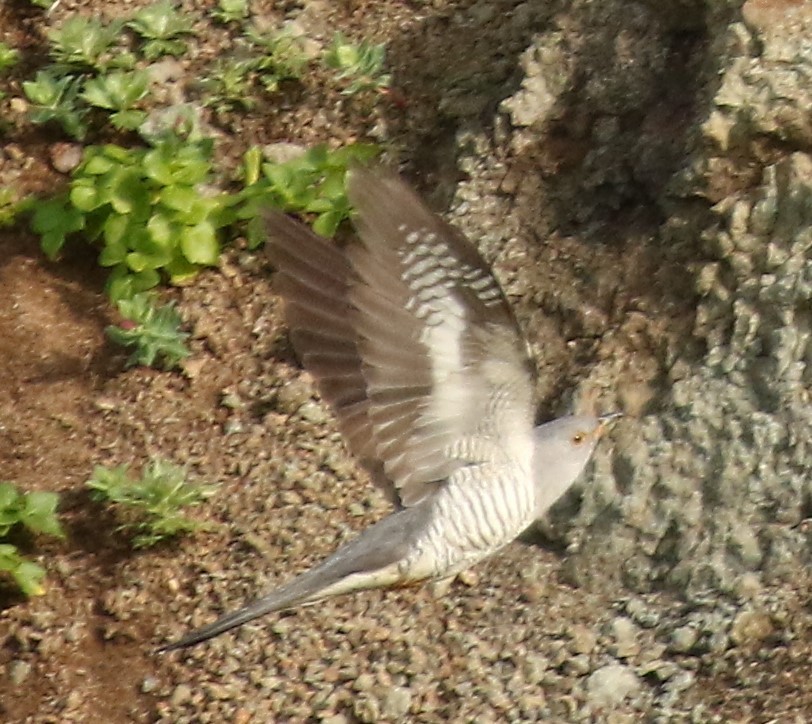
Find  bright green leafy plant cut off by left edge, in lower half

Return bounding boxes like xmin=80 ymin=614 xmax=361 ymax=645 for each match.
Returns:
xmin=0 ymin=482 xmax=64 ymax=596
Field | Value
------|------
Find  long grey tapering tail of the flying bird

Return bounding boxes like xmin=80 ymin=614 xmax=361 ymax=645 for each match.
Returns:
xmin=158 ymin=506 xmax=428 ymax=651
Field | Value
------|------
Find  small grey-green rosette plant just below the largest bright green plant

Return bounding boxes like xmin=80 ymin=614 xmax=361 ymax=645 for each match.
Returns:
xmin=105 ymin=292 xmax=189 ymax=370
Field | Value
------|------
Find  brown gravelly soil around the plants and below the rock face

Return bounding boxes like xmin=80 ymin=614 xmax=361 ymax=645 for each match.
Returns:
xmin=0 ymin=0 xmax=812 ymax=724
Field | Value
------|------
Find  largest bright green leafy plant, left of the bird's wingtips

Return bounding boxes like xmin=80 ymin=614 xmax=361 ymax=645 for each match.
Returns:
xmin=32 ymin=136 xmax=236 ymax=300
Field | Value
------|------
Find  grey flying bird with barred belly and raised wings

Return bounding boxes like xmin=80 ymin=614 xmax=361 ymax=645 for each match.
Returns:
xmin=160 ymin=167 xmax=619 ymax=651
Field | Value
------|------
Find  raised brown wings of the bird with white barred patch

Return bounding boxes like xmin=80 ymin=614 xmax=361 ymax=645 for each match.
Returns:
xmin=267 ymin=169 xmax=534 ymax=507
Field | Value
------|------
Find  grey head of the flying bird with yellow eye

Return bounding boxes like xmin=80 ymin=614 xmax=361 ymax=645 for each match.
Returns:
xmin=533 ymin=413 xmax=620 ymax=516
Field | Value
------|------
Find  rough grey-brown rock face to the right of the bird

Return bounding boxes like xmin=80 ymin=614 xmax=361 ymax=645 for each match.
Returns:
xmin=448 ymin=0 xmax=812 ymax=598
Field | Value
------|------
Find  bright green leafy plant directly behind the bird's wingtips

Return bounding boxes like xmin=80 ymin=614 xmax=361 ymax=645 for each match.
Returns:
xmin=239 ymin=143 xmax=380 ymax=243
